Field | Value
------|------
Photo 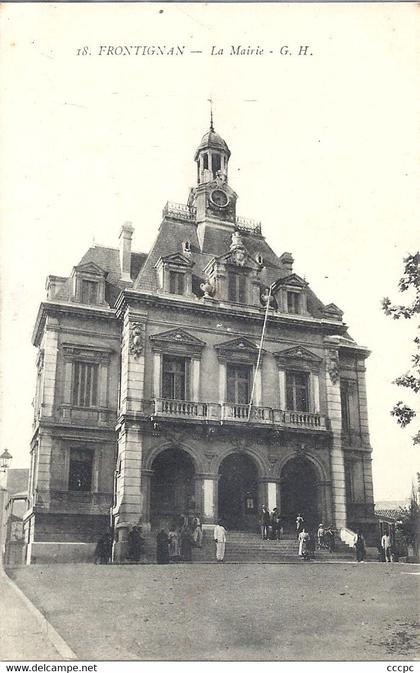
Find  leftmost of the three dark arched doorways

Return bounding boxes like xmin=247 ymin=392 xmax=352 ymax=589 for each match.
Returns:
xmin=150 ymin=448 xmax=196 ymax=528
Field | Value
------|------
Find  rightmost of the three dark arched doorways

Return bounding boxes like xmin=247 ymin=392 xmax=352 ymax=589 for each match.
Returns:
xmin=280 ymin=457 xmax=320 ymax=531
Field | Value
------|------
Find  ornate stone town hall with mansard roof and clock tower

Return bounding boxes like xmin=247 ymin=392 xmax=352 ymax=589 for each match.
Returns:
xmin=24 ymin=122 xmax=375 ymax=563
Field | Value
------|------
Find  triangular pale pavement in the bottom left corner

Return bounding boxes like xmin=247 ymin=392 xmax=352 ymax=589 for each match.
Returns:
xmin=0 ymin=567 xmax=75 ymax=661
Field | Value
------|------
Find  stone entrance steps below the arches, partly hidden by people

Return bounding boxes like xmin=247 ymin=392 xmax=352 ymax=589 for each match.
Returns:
xmin=139 ymin=531 xmax=356 ymax=563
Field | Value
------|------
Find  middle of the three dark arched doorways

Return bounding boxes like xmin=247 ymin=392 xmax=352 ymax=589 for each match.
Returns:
xmin=218 ymin=453 xmax=258 ymax=530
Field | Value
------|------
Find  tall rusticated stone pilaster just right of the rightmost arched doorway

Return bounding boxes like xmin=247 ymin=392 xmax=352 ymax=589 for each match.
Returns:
xmin=324 ymin=337 xmax=347 ymax=528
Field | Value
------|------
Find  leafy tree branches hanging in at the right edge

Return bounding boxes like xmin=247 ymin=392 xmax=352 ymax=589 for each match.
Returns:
xmin=382 ymin=252 xmax=420 ymax=444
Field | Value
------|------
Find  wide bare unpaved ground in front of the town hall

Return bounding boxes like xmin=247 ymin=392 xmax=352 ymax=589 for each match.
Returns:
xmin=10 ymin=563 xmax=420 ymax=660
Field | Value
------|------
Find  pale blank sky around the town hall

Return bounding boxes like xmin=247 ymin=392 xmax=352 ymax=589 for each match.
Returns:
xmin=0 ymin=3 xmax=420 ymax=500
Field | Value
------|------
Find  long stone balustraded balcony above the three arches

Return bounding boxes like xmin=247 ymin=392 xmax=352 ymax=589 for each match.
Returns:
xmin=153 ymin=397 xmax=328 ymax=432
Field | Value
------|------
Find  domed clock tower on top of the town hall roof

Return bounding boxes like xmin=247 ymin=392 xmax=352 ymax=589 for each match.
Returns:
xmin=188 ymin=116 xmax=237 ymax=229
